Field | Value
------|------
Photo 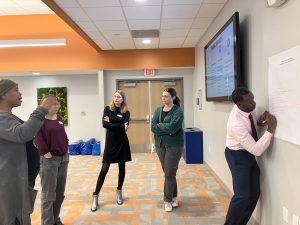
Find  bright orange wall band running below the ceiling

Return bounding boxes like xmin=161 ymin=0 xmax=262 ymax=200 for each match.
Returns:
xmin=0 ymin=14 xmax=195 ymax=72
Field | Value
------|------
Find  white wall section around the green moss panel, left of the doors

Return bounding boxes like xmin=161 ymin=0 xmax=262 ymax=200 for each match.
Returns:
xmin=5 ymin=74 xmax=102 ymax=143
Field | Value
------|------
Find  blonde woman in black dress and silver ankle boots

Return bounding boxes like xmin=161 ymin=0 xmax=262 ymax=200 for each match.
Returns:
xmin=91 ymin=90 xmax=131 ymax=212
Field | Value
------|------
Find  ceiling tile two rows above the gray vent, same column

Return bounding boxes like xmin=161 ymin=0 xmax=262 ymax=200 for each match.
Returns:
xmin=124 ymin=6 xmax=161 ymax=20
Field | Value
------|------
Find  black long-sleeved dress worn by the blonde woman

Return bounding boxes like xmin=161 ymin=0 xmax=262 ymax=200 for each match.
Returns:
xmin=102 ymin=106 xmax=131 ymax=163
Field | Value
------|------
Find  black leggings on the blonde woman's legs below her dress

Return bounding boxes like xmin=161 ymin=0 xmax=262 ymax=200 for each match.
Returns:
xmin=93 ymin=162 xmax=125 ymax=195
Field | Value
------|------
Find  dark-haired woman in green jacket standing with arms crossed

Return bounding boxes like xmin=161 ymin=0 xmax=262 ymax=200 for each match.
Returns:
xmin=151 ymin=88 xmax=183 ymax=212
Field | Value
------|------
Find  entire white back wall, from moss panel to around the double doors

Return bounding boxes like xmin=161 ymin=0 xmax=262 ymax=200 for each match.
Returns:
xmin=2 ymin=68 xmax=195 ymax=148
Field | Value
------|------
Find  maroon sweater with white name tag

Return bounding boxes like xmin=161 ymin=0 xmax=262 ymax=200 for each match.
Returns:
xmin=35 ymin=116 xmax=69 ymax=156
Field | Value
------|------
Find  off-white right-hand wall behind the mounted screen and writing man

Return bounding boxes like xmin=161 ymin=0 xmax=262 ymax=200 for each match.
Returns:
xmin=194 ymin=0 xmax=300 ymax=225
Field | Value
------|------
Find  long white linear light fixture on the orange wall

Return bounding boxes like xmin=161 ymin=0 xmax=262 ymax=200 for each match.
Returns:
xmin=0 ymin=38 xmax=66 ymax=48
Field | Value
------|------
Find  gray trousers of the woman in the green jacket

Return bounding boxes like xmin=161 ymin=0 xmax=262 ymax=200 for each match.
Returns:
xmin=156 ymin=147 xmax=182 ymax=202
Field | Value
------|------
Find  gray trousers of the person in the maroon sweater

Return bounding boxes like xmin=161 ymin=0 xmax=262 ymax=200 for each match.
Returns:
xmin=40 ymin=153 xmax=69 ymax=225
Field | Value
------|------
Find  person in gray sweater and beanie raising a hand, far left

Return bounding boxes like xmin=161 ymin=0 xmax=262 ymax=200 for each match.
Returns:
xmin=0 ymin=79 xmax=57 ymax=225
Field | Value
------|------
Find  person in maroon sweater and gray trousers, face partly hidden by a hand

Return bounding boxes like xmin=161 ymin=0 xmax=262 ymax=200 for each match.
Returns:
xmin=35 ymin=95 xmax=69 ymax=225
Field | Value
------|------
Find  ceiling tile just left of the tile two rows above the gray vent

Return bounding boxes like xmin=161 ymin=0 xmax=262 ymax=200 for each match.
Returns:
xmin=84 ymin=7 xmax=125 ymax=20
